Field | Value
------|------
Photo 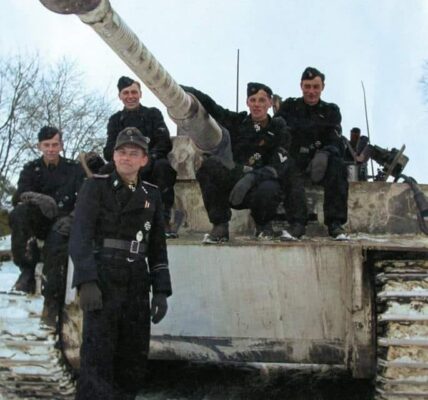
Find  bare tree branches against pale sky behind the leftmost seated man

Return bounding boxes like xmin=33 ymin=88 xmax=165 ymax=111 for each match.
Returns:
xmin=0 ymin=55 xmax=112 ymax=205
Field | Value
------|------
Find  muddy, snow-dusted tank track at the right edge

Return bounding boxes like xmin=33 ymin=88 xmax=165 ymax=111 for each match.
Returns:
xmin=375 ymin=259 xmax=428 ymax=400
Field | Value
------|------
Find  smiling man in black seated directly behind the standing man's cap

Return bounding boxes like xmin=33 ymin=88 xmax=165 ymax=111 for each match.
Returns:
xmin=104 ymin=76 xmax=177 ymax=238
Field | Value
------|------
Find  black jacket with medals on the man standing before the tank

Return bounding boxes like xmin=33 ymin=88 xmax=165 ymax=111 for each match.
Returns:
xmin=69 ymin=171 xmax=171 ymax=295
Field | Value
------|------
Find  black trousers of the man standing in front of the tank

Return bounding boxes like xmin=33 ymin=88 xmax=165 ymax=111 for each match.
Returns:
xmin=76 ymin=258 xmax=150 ymax=400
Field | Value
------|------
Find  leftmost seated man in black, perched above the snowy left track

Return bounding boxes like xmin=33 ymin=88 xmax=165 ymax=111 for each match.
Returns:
xmin=9 ymin=126 xmax=84 ymax=303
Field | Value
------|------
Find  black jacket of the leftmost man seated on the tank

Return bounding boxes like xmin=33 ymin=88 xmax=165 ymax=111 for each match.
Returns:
xmin=12 ymin=157 xmax=85 ymax=215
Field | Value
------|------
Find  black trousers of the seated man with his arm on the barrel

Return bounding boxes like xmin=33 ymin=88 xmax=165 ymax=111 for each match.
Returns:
xmin=196 ymin=157 xmax=281 ymax=225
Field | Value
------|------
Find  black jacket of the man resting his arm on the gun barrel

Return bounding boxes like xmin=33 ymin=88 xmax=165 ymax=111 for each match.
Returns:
xmin=182 ymin=86 xmax=291 ymax=173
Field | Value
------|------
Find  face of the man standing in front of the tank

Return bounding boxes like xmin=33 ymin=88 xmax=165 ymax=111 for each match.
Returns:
xmin=113 ymin=144 xmax=149 ymax=180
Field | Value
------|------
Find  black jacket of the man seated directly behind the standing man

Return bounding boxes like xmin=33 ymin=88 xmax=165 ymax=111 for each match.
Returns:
xmin=104 ymin=104 xmax=172 ymax=161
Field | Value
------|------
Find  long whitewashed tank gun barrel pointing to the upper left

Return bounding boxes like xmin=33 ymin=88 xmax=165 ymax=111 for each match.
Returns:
xmin=40 ymin=0 xmax=233 ymax=168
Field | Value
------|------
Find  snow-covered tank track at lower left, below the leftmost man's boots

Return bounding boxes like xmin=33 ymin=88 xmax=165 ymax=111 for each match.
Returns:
xmin=0 ymin=292 xmax=75 ymax=400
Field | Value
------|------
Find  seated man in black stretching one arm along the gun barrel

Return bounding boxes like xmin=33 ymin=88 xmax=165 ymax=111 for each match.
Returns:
xmin=183 ymin=82 xmax=306 ymax=243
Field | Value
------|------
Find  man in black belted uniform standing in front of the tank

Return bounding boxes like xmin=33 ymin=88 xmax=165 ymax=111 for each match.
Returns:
xmin=70 ymin=127 xmax=172 ymax=400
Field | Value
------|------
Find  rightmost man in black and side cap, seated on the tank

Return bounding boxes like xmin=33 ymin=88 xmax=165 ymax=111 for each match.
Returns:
xmin=276 ymin=67 xmax=348 ymax=239
